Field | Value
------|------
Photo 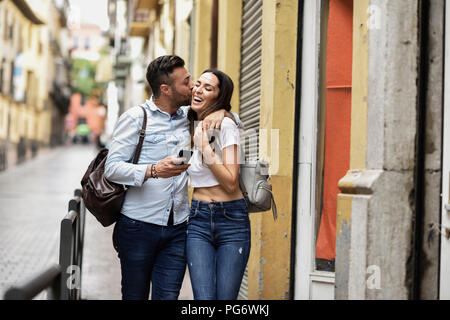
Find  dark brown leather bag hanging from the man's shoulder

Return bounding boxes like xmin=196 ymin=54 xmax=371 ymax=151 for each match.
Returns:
xmin=81 ymin=106 xmax=147 ymax=227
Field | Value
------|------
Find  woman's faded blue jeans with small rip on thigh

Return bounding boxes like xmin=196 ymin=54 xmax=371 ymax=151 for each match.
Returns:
xmin=186 ymin=199 xmax=251 ymax=300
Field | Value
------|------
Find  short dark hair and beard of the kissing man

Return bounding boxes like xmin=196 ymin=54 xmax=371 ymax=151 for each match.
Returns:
xmin=146 ymin=56 xmax=184 ymax=98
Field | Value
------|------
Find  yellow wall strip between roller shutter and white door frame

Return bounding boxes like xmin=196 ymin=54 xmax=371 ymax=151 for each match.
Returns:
xmin=252 ymin=0 xmax=298 ymax=299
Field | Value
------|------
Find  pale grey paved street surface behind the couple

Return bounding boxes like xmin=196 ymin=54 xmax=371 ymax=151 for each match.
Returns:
xmin=0 ymin=145 xmax=192 ymax=300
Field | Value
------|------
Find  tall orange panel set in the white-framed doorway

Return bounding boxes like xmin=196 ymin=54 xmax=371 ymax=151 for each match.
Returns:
xmin=316 ymin=0 xmax=353 ymax=271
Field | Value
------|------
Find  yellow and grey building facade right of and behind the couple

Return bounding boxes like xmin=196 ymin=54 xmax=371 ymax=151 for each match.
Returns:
xmin=109 ymin=0 xmax=450 ymax=299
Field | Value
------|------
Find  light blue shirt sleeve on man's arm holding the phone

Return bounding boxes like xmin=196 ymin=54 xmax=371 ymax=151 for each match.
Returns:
xmin=105 ymin=113 xmax=147 ymax=187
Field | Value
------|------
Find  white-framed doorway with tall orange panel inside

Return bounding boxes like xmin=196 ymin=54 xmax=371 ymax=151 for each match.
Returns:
xmin=295 ymin=0 xmax=353 ymax=300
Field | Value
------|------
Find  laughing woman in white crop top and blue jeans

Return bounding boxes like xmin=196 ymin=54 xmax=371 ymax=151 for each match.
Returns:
xmin=186 ymin=70 xmax=250 ymax=300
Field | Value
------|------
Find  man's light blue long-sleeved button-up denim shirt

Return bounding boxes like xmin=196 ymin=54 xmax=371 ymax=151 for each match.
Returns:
xmin=105 ymin=97 xmax=239 ymax=226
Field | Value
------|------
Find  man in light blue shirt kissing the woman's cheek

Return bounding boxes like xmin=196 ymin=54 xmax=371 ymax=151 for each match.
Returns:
xmin=105 ymin=56 xmax=239 ymax=300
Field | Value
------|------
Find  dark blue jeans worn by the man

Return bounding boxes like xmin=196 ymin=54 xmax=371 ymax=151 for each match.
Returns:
xmin=113 ymin=215 xmax=186 ymax=300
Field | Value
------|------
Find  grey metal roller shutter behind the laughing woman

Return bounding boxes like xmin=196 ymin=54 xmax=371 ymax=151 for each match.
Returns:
xmin=238 ymin=0 xmax=262 ymax=300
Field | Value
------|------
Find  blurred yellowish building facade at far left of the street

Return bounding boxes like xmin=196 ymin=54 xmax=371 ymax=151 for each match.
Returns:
xmin=0 ymin=0 xmax=70 ymax=170
